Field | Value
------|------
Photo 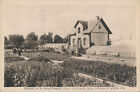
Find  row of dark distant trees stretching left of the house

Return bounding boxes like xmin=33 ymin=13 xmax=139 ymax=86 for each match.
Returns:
xmin=4 ymin=32 xmax=67 ymax=49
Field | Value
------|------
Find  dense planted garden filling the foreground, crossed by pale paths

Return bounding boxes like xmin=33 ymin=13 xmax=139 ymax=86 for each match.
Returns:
xmin=4 ymin=52 xmax=136 ymax=87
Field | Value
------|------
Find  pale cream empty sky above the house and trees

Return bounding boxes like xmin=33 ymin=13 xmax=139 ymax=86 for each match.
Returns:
xmin=2 ymin=0 xmax=139 ymax=41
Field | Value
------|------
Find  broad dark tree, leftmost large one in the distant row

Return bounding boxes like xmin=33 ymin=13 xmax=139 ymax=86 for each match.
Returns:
xmin=9 ymin=35 xmax=24 ymax=48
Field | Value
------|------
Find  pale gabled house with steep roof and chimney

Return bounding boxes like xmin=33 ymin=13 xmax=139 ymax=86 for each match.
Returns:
xmin=68 ymin=16 xmax=112 ymax=48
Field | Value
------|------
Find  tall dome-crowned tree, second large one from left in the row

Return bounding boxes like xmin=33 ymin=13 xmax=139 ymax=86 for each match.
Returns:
xmin=22 ymin=32 xmax=38 ymax=49
